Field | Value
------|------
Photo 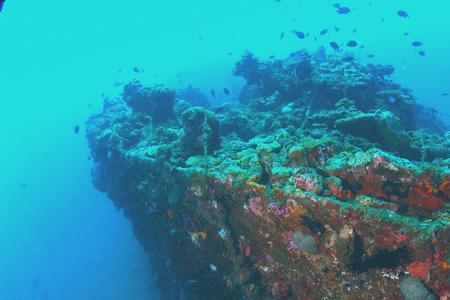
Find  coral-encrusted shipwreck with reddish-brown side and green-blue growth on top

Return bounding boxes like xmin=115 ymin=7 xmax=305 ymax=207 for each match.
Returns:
xmin=87 ymin=51 xmax=450 ymax=300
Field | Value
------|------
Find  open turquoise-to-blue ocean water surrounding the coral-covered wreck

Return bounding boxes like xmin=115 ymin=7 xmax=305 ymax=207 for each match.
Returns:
xmin=0 ymin=0 xmax=450 ymax=300
